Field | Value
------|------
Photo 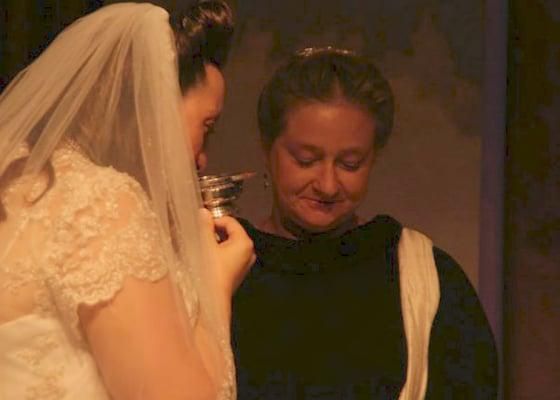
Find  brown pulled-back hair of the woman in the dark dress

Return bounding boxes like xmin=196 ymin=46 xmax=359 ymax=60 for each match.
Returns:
xmin=257 ymin=47 xmax=394 ymax=151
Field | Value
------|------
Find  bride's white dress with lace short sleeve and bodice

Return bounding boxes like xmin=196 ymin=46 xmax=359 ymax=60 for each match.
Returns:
xmin=0 ymin=146 xmax=195 ymax=400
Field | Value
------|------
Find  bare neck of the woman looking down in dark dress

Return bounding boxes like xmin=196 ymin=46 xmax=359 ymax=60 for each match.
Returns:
xmin=257 ymin=208 xmax=359 ymax=239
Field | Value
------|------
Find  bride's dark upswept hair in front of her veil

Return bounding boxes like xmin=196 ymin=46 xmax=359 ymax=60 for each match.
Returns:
xmin=169 ymin=0 xmax=234 ymax=93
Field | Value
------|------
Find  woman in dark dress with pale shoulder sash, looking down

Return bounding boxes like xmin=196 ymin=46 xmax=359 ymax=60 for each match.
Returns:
xmin=233 ymin=48 xmax=497 ymax=400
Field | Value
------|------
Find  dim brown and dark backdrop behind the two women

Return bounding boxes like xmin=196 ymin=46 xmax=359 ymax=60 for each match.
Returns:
xmin=0 ymin=0 xmax=560 ymax=399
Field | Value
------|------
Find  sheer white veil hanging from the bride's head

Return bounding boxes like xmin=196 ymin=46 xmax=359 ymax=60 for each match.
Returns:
xmin=0 ymin=3 xmax=231 ymax=396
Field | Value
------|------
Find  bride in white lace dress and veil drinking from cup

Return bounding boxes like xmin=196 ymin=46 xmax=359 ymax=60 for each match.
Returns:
xmin=0 ymin=0 xmax=254 ymax=400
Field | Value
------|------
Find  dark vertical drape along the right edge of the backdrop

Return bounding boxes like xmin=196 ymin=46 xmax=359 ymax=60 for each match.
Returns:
xmin=504 ymin=0 xmax=560 ymax=400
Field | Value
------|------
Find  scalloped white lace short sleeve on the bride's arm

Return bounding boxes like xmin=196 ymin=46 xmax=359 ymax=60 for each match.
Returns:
xmin=45 ymin=170 xmax=168 ymax=341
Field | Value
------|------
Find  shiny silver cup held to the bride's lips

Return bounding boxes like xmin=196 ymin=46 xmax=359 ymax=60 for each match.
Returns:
xmin=198 ymin=172 xmax=255 ymax=218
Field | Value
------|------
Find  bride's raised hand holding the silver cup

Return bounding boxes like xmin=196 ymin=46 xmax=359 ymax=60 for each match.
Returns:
xmin=200 ymin=209 xmax=256 ymax=298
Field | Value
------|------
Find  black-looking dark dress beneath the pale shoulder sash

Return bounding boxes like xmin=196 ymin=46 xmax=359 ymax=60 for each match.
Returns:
xmin=233 ymin=216 xmax=497 ymax=400
